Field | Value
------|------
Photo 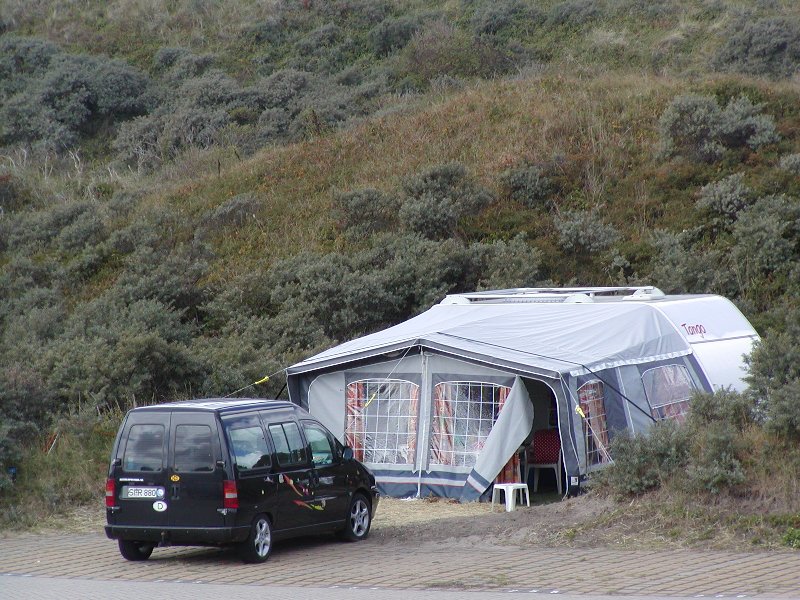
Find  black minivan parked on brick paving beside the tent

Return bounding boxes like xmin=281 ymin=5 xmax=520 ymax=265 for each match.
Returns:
xmin=105 ymin=398 xmax=379 ymax=562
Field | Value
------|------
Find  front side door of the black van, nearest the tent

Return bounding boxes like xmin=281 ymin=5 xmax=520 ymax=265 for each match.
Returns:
xmin=301 ymin=420 xmax=350 ymax=524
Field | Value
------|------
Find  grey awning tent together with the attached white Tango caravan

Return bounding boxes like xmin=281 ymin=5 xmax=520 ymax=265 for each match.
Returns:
xmin=287 ymin=288 xmax=757 ymax=498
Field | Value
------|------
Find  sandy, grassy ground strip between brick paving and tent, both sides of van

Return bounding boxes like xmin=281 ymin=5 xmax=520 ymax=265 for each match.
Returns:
xmin=6 ymin=494 xmax=786 ymax=550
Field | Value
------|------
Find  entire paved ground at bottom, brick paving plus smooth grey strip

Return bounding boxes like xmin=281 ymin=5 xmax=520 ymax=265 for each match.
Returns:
xmin=0 ymin=533 xmax=800 ymax=600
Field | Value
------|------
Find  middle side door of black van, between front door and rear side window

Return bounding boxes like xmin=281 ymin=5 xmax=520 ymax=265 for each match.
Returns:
xmin=267 ymin=417 xmax=317 ymax=530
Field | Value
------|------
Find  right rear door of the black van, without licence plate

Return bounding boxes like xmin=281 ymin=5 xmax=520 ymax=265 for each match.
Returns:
xmin=167 ymin=411 xmax=225 ymax=528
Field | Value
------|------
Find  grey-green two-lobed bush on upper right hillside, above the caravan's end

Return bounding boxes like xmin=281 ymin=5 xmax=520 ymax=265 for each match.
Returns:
xmin=659 ymin=94 xmax=778 ymax=162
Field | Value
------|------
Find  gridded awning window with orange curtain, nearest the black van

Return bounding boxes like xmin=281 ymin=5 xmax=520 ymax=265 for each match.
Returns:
xmin=345 ymin=379 xmax=419 ymax=465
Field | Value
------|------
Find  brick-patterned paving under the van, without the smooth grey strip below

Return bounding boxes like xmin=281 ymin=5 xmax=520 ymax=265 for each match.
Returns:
xmin=0 ymin=535 xmax=800 ymax=598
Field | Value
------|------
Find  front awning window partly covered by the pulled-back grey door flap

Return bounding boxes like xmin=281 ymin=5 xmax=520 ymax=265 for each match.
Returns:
xmin=430 ymin=381 xmax=511 ymax=467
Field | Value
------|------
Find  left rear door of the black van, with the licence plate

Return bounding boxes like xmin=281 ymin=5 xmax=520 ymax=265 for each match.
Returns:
xmin=109 ymin=412 xmax=169 ymax=529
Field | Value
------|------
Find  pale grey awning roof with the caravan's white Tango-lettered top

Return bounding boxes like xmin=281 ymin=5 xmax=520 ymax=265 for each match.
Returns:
xmin=288 ymin=286 xmax=758 ymax=388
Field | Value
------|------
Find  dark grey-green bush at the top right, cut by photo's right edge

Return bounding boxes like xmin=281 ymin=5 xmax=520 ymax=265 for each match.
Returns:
xmin=712 ymin=17 xmax=800 ymax=77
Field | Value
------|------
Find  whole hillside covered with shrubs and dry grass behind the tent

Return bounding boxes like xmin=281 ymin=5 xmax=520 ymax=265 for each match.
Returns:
xmin=0 ymin=0 xmax=800 ymax=544
